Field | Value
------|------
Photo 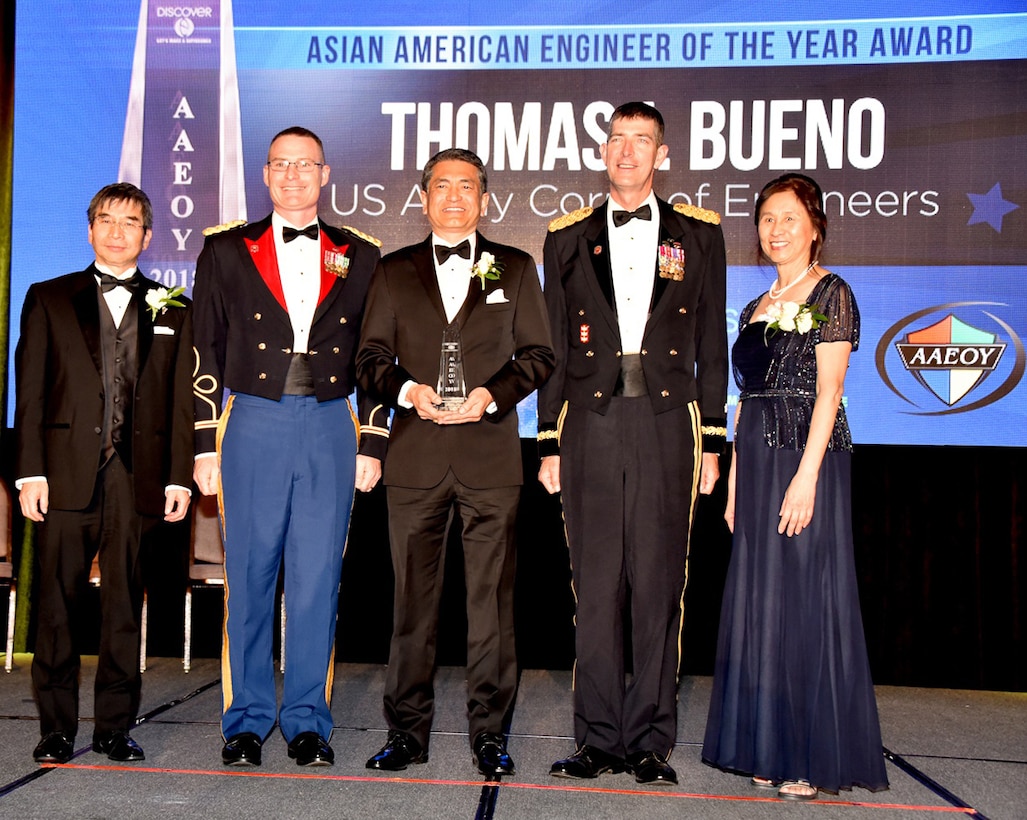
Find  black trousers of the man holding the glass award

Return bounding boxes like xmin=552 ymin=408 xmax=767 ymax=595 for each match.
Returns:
xmin=384 ymin=472 xmax=521 ymax=750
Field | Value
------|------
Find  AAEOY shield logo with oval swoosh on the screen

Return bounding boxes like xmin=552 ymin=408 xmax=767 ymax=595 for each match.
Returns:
xmin=874 ymin=302 xmax=1027 ymax=416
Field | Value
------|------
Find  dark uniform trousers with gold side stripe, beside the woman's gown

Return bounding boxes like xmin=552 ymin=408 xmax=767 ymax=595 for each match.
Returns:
xmin=560 ymin=397 xmax=700 ymax=756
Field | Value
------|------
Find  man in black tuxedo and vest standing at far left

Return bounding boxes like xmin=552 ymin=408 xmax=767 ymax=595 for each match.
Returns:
xmin=14 ymin=183 xmax=193 ymax=763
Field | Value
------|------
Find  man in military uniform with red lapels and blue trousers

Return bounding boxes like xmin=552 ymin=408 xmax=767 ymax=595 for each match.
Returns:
xmin=194 ymin=126 xmax=388 ymax=766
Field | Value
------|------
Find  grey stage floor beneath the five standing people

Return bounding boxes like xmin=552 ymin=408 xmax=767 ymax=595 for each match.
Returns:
xmin=0 ymin=655 xmax=1027 ymax=820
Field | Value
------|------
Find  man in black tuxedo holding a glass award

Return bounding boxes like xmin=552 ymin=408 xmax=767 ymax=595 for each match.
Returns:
xmin=356 ymin=148 xmax=553 ymax=778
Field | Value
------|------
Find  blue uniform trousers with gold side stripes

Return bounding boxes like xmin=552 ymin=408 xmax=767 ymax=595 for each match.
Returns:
xmin=218 ymin=394 xmax=357 ymax=741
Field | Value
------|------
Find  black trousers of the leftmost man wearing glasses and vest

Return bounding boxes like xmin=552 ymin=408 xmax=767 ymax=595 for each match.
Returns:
xmin=32 ymin=455 xmax=149 ymax=738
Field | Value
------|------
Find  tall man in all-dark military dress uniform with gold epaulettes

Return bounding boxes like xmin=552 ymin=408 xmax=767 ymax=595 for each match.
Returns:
xmin=538 ymin=103 xmax=727 ymax=783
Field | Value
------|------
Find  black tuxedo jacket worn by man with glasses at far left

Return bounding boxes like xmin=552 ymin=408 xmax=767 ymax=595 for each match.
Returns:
xmin=14 ymin=265 xmax=193 ymax=516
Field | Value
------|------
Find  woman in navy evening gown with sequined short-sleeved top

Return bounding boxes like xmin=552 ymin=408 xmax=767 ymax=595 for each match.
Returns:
xmin=702 ymin=175 xmax=887 ymax=799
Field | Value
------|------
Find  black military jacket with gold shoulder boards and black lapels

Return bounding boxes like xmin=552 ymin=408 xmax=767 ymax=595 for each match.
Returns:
xmin=538 ymin=199 xmax=727 ymax=455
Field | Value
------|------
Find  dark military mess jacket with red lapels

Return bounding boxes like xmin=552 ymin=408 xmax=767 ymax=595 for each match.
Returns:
xmin=193 ymin=214 xmax=388 ymax=458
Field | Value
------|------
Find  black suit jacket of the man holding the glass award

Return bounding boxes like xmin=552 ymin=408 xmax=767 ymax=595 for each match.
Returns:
xmin=356 ymin=233 xmax=554 ymax=489
